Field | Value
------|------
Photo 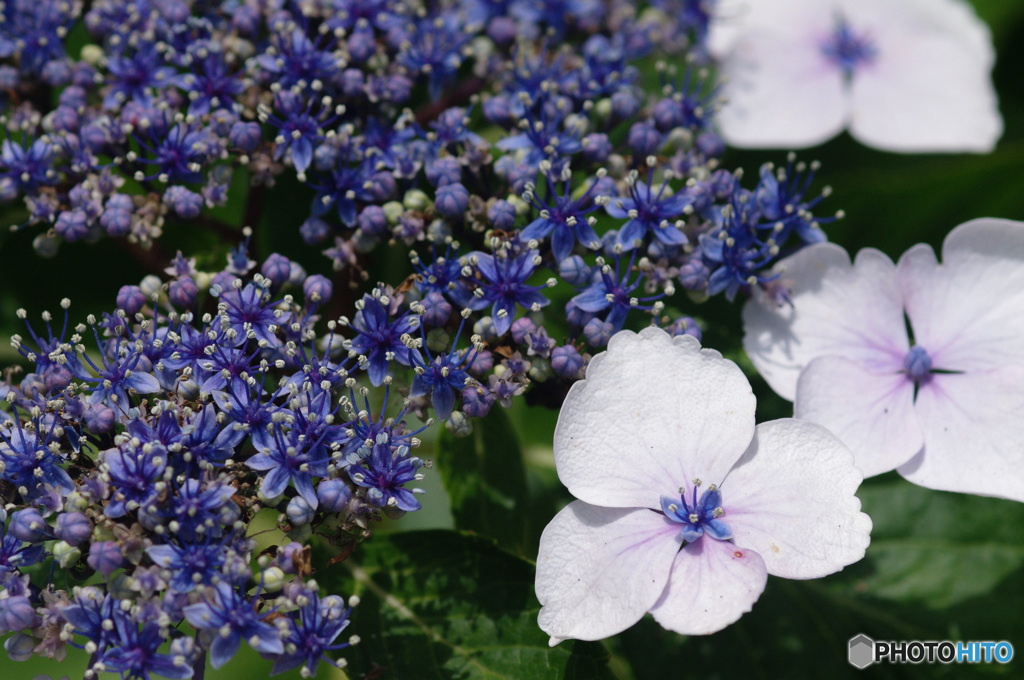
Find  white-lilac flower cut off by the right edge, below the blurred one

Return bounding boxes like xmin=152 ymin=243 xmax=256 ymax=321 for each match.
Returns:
xmin=743 ymin=219 xmax=1024 ymax=501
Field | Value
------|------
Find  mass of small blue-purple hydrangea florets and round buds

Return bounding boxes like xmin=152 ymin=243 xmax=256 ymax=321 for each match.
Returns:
xmin=0 ymin=0 xmax=851 ymax=678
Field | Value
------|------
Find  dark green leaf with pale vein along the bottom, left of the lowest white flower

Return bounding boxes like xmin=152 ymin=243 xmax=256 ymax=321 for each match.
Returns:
xmin=335 ymin=530 xmax=612 ymax=680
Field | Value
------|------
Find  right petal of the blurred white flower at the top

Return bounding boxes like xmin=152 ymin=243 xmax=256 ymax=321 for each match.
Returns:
xmin=850 ymin=0 xmax=1002 ymax=153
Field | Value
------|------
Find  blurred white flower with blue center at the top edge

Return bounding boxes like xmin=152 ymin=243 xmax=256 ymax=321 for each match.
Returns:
xmin=709 ymin=0 xmax=1002 ymax=153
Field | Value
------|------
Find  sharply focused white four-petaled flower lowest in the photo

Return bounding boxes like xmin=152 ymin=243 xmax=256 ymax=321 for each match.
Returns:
xmin=536 ymin=328 xmax=871 ymax=644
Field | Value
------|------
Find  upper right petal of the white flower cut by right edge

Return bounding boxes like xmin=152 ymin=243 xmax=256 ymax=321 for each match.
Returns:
xmin=898 ymin=219 xmax=1024 ymax=371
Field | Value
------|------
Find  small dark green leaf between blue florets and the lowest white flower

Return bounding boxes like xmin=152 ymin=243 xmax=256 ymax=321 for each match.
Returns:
xmin=435 ymin=407 xmax=526 ymax=552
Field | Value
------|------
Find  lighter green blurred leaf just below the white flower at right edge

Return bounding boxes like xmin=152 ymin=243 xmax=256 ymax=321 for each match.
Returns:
xmin=827 ymin=473 xmax=1024 ymax=608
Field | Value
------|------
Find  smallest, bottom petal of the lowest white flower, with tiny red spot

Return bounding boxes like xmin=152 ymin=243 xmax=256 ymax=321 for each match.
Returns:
xmin=650 ymin=537 xmax=768 ymax=635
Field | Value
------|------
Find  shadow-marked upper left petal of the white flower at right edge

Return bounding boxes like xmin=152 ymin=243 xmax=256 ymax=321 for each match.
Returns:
xmin=743 ymin=243 xmax=909 ymax=400
